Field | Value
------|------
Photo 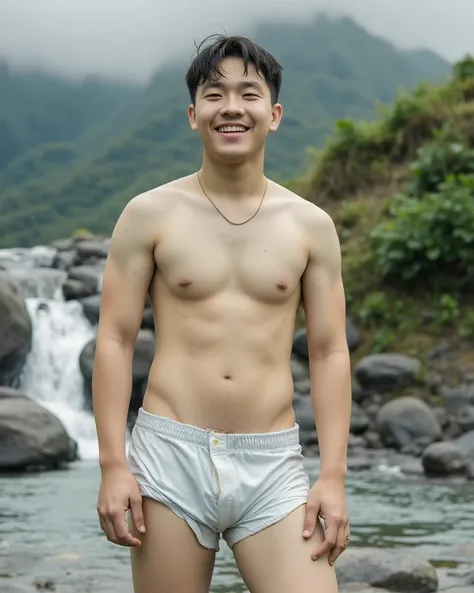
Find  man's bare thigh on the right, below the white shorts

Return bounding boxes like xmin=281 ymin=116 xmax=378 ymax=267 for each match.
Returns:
xmin=233 ymin=505 xmax=338 ymax=593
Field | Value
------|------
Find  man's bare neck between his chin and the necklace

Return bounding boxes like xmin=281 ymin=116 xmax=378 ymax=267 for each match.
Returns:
xmin=199 ymin=155 xmax=266 ymax=200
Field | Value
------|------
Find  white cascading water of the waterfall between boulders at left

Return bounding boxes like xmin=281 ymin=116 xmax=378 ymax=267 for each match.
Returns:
xmin=0 ymin=247 xmax=98 ymax=459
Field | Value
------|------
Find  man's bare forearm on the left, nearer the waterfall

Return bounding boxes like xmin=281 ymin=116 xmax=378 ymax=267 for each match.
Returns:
xmin=92 ymin=339 xmax=134 ymax=468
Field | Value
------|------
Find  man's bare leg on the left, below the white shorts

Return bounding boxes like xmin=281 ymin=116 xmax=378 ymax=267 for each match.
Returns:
xmin=129 ymin=497 xmax=215 ymax=593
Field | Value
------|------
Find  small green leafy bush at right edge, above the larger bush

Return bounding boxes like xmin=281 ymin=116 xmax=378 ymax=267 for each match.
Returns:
xmin=410 ymin=142 xmax=474 ymax=196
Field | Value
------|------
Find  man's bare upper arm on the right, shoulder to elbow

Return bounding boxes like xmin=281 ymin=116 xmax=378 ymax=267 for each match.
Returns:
xmin=302 ymin=205 xmax=347 ymax=358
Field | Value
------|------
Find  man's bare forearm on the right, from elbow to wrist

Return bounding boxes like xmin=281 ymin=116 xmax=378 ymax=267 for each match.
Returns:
xmin=310 ymin=351 xmax=352 ymax=478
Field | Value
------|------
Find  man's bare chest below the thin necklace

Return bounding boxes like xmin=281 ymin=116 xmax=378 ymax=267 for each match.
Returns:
xmin=155 ymin=213 xmax=307 ymax=302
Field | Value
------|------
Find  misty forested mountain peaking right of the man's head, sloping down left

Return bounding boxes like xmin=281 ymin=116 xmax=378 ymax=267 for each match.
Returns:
xmin=0 ymin=17 xmax=450 ymax=246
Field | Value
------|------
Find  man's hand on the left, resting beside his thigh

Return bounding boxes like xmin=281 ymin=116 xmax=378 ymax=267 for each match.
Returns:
xmin=97 ymin=467 xmax=145 ymax=547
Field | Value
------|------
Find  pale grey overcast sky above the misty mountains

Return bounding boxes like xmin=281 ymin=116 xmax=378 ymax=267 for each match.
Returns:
xmin=0 ymin=0 xmax=474 ymax=82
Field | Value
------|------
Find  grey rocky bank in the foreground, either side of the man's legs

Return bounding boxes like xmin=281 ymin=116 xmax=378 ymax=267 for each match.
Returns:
xmin=0 ymin=548 xmax=474 ymax=593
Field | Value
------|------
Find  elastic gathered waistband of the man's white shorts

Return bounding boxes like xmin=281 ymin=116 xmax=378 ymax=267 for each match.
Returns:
xmin=135 ymin=408 xmax=300 ymax=450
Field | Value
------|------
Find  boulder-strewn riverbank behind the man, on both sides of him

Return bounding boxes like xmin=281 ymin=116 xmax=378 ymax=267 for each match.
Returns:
xmin=0 ymin=239 xmax=474 ymax=479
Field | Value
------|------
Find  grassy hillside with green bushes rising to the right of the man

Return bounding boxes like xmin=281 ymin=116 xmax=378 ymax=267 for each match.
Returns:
xmin=293 ymin=58 xmax=474 ymax=384
